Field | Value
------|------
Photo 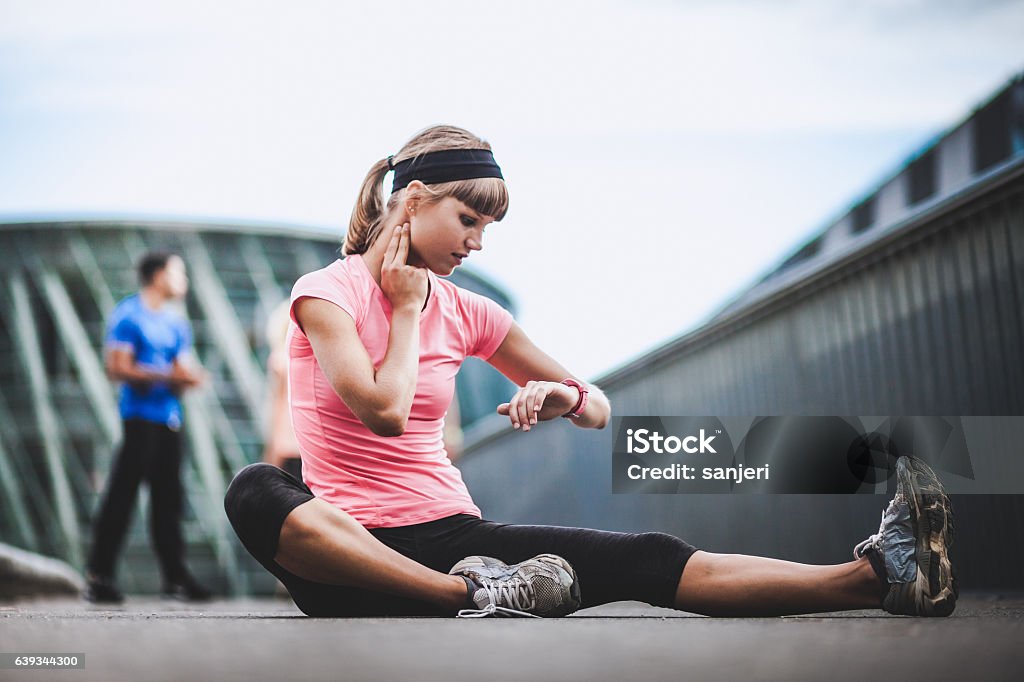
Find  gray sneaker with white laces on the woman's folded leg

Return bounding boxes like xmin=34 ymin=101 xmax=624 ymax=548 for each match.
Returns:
xmin=449 ymin=554 xmax=581 ymax=619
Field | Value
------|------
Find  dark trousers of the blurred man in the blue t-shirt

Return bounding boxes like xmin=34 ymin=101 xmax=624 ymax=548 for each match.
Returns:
xmin=88 ymin=419 xmax=185 ymax=582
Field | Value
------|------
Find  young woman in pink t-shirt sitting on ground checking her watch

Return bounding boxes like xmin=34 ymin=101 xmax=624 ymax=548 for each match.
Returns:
xmin=225 ymin=126 xmax=956 ymax=616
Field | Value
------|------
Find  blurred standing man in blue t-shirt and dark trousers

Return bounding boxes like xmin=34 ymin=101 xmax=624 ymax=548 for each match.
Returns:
xmin=85 ymin=252 xmax=211 ymax=603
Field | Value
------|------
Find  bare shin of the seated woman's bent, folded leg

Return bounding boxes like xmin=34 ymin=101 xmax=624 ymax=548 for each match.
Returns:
xmin=273 ymin=499 xmax=466 ymax=611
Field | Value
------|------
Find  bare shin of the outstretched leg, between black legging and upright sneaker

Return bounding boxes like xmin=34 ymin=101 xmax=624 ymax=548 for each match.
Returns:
xmin=676 ymin=552 xmax=883 ymax=616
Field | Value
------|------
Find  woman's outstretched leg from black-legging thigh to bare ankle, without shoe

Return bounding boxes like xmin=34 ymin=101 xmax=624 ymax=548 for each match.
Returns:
xmin=405 ymin=520 xmax=883 ymax=615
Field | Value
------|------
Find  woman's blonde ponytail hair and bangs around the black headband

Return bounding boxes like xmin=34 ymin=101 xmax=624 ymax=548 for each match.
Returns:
xmin=343 ymin=126 xmax=509 ymax=256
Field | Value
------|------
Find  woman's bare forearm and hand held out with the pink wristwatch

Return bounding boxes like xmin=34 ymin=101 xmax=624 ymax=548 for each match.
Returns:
xmin=487 ymin=323 xmax=611 ymax=431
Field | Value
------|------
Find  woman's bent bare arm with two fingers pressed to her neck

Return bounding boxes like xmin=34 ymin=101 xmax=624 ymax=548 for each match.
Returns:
xmin=295 ymin=225 xmax=427 ymax=436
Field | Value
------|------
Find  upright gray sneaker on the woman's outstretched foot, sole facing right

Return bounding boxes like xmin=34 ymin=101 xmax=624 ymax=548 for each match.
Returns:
xmin=853 ymin=457 xmax=957 ymax=615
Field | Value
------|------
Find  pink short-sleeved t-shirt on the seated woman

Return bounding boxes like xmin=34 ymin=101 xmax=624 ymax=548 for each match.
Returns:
xmin=288 ymin=255 xmax=512 ymax=528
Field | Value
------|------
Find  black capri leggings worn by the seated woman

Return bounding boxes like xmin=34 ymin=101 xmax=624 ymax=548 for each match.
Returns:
xmin=224 ymin=463 xmax=696 ymax=617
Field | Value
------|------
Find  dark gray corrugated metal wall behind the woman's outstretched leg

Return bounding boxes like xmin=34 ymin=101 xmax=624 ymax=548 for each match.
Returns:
xmin=463 ymin=152 xmax=1024 ymax=588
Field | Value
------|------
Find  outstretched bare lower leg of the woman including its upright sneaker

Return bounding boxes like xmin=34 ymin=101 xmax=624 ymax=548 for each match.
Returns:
xmin=676 ymin=457 xmax=957 ymax=616
